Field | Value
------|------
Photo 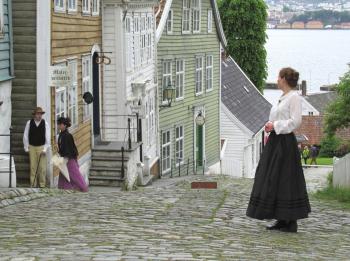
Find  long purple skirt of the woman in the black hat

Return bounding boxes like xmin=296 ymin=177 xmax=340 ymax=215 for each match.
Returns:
xmin=58 ymin=159 xmax=88 ymax=192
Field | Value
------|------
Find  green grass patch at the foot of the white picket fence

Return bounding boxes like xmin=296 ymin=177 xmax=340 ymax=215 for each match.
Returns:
xmin=313 ymin=173 xmax=350 ymax=209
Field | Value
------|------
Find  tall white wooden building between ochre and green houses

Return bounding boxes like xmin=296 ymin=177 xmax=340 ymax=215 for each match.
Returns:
xmin=101 ymin=0 xmax=159 ymax=174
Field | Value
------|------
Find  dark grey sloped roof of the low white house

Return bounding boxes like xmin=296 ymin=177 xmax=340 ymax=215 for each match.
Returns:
xmin=221 ymin=57 xmax=272 ymax=134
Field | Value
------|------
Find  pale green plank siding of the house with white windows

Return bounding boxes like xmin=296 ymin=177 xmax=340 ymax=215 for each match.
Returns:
xmin=157 ymin=0 xmax=220 ymax=175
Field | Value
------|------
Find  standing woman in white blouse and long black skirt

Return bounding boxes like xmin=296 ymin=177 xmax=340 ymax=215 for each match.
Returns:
xmin=247 ymin=68 xmax=311 ymax=232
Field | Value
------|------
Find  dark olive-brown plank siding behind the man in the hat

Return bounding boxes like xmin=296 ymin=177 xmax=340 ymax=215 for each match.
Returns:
xmin=12 ymin=0 xmax=37 ymax=182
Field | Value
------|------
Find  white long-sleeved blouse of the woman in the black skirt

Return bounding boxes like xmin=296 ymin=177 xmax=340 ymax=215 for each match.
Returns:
xmin=269 ymin=91 xmax=302 ymax=135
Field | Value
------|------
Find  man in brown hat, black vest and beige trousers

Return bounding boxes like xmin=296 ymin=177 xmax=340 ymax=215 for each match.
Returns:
xmin=23 ymin=107 xmax=50 ymax=188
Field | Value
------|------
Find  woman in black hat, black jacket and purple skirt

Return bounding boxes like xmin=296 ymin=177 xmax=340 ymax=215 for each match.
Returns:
xmin=57 ymin=117 xmax=88 ymax=192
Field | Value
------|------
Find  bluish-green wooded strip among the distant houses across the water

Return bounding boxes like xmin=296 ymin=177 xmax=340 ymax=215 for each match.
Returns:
xmin=289 ymin=9 xmax=350 ymax=25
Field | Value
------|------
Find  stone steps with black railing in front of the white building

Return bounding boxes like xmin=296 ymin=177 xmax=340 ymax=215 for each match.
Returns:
xmin=89 ymin=142 xmax=151 ymax=187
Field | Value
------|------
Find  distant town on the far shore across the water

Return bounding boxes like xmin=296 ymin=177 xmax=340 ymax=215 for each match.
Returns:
xmin=266 ymin=0 xmax=350 ymax=29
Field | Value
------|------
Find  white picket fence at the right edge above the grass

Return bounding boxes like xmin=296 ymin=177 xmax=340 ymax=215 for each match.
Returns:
xmin=333 ymin=153 xmax=350 ymax=187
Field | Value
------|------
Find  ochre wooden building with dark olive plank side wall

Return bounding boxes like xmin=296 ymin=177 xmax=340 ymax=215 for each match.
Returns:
xmin=12 ymin=0 xmax=102 ymax=181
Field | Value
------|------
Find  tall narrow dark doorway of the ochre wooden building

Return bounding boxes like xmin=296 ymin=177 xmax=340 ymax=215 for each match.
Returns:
xmin=92 ymin=52 xmax=100 ymax=139
